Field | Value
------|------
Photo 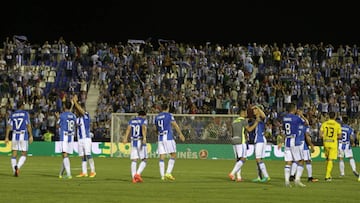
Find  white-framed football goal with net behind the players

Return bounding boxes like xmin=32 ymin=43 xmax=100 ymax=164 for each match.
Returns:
xmin=110 ymin=113 xmax=238 ymax=157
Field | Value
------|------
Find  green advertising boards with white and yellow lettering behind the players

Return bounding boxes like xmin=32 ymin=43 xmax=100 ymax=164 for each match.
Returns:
xmin=0 ymin=141 xmax=360 ymax=161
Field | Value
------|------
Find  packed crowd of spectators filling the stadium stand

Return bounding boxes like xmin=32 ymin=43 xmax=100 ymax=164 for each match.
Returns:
xmin=0 ymin=37 xmax=360 ymax=144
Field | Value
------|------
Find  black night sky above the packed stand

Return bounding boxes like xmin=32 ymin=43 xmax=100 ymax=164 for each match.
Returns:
xmin=0 ymin=0 xmax=360 ymax=45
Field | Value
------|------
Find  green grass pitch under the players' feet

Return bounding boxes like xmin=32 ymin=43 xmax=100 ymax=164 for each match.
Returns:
xmin=0 ymin=156 xmax=360 ymax=203
